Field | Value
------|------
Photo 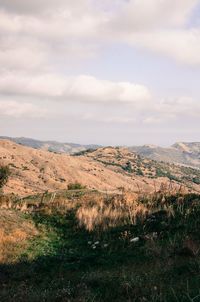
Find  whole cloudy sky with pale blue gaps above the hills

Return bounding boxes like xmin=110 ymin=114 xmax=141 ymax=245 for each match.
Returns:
xmin=0 ymin=0 xmax=200 ymax=145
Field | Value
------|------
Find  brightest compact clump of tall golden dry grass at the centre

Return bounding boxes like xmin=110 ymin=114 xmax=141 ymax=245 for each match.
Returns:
xmin=76 ymin=193 xmax=148 ymax=231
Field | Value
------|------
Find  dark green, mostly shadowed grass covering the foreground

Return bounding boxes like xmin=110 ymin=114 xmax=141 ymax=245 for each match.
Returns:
xmin=0 ymin=195 xmax=200 ymax=302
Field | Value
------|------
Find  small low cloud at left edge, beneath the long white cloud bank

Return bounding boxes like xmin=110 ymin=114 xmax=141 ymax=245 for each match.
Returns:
xmin=0 ymin=101 xmax=45 ymax=118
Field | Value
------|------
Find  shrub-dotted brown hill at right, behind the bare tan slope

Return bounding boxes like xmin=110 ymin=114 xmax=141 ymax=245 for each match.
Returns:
xmin=86 ymin=147 xmax=200 ymax=187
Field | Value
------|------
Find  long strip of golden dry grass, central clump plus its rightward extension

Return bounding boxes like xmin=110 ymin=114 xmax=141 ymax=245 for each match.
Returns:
xmin=76 ymin=184 xmax=187 ymax=231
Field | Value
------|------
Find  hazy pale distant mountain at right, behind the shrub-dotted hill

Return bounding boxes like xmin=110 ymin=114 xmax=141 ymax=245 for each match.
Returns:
xmin=129 ymin=142 xmax=200 ymax=169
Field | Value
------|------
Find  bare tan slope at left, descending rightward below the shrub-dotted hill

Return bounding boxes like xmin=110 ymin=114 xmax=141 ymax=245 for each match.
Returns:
xmin=0 ymin=140 xmax=166 ymax=195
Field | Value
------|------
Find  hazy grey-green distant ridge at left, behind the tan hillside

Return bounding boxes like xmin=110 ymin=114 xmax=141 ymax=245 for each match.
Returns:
xmin=0 ymin=136 xmax=100 ymax=154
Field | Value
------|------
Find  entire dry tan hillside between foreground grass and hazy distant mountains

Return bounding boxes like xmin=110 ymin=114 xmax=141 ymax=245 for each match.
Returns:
xmin=0 ymin=140 xmax=200 ymax=196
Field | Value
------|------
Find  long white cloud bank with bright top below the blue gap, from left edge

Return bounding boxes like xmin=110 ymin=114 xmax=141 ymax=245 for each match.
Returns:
xmin=0 ymin=72 xmax=151 ymax=107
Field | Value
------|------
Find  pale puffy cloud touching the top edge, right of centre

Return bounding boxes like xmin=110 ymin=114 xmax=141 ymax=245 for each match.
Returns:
xmin=112 ymin=0 xmax=198 ymax=33
